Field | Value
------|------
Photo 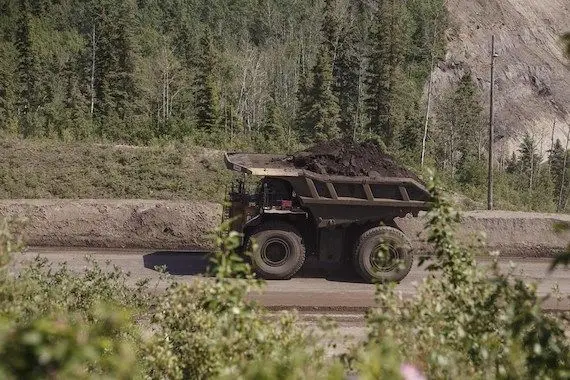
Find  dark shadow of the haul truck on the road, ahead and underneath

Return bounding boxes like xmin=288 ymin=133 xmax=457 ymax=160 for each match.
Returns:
xmin=143 ymin=251 xmax=362 ymax=282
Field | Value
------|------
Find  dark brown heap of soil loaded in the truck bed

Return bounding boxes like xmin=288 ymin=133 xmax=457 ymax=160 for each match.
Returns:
xmin=288 ymin=140 xmax=420 ymax=181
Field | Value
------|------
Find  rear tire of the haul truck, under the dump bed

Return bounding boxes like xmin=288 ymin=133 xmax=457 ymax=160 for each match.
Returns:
xmin=353 ymin=226 xmax=414 ymax=282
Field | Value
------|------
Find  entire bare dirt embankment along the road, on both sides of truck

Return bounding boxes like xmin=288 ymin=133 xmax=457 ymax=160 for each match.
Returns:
xmin=0 ymin=200 xmax=570 ymax=257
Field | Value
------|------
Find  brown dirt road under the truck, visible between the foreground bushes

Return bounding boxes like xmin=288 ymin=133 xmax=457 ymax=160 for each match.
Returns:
xmin=17 ymin=248 xmax=570 ymax=315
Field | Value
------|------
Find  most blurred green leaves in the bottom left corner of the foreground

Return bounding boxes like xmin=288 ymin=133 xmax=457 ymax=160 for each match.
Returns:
xmin=0 ymin=309 xmax=136 ymax=380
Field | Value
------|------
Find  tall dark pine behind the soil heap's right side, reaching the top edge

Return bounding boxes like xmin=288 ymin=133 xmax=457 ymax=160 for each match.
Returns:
xmin=366 ymin=0 xmax=406 ymax=146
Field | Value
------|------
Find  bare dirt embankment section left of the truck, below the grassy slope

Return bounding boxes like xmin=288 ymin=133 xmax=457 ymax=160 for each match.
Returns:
xmin=0 ymin=200 xmax=221 ymax=249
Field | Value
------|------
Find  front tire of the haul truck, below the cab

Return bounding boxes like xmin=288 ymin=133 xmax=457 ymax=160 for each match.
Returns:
xmin=248 ymin=222 xmax=305 ymax=280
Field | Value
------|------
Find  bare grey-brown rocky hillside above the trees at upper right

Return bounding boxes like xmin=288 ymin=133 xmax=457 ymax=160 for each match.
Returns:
xmin=434 ymin=0 xmax=570 ymax=156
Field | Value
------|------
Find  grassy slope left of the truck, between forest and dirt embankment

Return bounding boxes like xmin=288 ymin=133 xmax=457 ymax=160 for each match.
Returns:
xmin=0 ymin=138 xmax=231 ymax=202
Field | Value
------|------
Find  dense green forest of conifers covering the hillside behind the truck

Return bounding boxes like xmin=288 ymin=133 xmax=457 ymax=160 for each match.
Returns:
xmin=0 ymin=0 xmax=570 ymax=210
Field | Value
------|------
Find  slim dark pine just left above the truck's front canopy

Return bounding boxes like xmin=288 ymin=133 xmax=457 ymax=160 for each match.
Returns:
xmin=196 ymin=31 xmax=220 ymax=132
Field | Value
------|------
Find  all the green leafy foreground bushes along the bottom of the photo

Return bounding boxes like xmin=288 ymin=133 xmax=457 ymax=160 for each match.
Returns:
xmin=0 ymin=175 xmax=570 ymax=380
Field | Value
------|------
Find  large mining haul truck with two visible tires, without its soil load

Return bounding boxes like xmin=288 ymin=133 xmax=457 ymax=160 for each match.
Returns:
xmin=225 ymin=153 xmax=429 ymax=282
